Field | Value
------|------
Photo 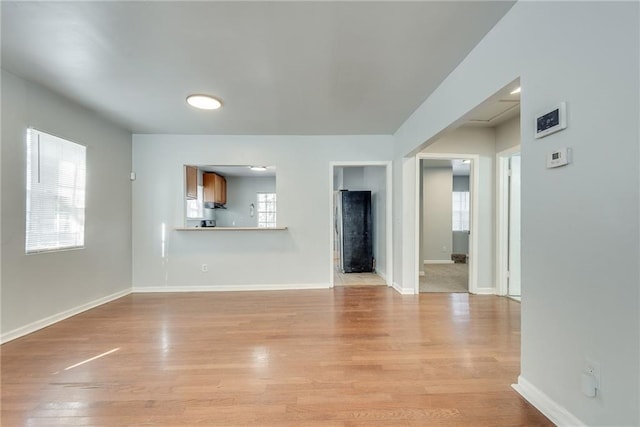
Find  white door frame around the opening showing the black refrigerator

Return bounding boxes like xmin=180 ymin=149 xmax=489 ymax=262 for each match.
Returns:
xmin=329 ymin=161 xmax=393 ymax=288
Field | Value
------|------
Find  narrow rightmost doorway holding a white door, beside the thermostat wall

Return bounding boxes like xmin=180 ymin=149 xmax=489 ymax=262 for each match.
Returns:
xmin=498 ymin=147 xmax=522 ymax=301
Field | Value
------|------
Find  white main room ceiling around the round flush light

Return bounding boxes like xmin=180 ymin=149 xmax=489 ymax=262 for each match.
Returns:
xmin=1 ymin=1 xmax=514 ymax=134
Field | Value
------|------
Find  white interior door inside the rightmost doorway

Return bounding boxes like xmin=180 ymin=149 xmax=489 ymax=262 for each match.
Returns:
xmin=508 ymin=153 xmax=521 ymax=297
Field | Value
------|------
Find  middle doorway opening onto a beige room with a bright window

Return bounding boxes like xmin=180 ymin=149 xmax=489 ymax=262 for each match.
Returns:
xmin=416 ymin=153 xmax=478 ymax=293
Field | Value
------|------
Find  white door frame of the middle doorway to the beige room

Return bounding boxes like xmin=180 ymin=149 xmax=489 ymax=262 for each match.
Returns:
xmin=413 ymin=153 xmax=480 ymax=294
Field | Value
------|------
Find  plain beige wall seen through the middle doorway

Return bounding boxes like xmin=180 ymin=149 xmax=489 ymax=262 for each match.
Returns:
xmin=422 ymin=166 xmax=453 ymax=262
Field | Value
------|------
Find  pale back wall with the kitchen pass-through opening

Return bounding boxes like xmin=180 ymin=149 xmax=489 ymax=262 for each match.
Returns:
xmin=133 ymin=135 xmax=393 ymax=290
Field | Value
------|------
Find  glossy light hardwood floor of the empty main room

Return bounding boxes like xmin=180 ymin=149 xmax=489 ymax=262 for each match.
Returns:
xmin=1 ymin=286 xmax=552 ymax=426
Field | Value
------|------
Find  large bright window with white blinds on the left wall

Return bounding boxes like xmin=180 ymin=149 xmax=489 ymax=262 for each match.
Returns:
xmin=25 ymin=129 xmax=86 ymax=253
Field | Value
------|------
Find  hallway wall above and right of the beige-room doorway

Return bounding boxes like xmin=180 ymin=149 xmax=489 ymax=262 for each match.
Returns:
xmin=422 ymin=127 xmax=496 ymax=293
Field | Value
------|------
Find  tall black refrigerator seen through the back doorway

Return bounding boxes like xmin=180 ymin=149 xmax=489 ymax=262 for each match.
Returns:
xmin=335 ymin=190 xmax=373 ymax=273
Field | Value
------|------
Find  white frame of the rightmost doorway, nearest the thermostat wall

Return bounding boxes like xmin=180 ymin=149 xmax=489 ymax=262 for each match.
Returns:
xmin=496 ymin=145 xmax=520 ymax=295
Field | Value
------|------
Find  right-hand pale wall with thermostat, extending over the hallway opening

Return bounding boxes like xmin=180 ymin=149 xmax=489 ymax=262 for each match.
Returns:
xmin=394 ymin=2 xmax=640 ymax=426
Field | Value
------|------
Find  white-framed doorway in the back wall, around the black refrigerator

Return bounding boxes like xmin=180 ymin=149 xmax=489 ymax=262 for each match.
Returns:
xmin=330 ymin=161 xmax=393 ymax=287
